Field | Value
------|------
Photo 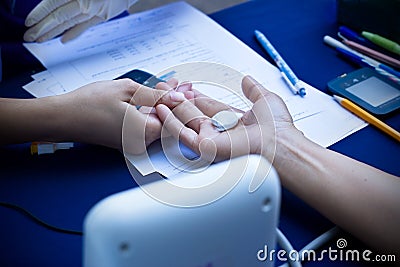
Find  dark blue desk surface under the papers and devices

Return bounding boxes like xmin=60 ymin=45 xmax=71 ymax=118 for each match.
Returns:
xmin=0 ymin=0 xmax=400 ymax=266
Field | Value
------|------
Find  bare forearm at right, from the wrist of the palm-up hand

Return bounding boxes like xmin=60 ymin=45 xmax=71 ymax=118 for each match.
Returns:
xmin=264 ymin=133 xmax=400 ymax=253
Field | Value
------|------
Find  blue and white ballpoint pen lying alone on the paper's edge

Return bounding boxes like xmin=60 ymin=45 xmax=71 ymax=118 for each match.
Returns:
xmin=254 ymin=30 xmax=306 ymax=97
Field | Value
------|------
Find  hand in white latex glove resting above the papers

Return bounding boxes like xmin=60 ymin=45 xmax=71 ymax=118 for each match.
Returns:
xmin=24 ymin=0 xmax=137 ymax=42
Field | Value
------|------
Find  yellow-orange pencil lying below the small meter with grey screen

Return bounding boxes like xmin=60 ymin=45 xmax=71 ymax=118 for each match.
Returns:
xmin=333 ymin=95 xmax=400 ymax=142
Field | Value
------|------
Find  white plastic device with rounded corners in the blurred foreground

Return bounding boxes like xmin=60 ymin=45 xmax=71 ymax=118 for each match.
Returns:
xmin=83 ymin=155 xmax=281 ymax=267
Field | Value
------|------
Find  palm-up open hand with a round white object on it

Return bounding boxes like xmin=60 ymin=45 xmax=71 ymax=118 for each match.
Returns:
xmin=156 ymin=76 xmax=302 ymax=162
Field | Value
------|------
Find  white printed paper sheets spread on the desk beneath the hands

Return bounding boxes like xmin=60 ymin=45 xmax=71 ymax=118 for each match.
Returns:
xmin=21 ymin=2 xmax=365 ymax=176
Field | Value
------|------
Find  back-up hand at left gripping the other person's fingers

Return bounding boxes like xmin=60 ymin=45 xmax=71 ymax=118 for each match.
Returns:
xmin=42 ymin=79 xmax=186 ymax=154
